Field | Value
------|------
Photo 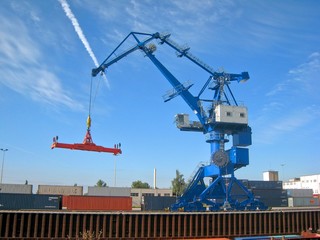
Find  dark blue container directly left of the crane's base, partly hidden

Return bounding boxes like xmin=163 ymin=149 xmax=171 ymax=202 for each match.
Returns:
xmin=141 ymin=196 xmax=177 ymax=211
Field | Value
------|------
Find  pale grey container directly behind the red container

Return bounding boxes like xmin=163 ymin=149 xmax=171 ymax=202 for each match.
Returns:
xmin=88 ymin=187 xmax=131 ymax=197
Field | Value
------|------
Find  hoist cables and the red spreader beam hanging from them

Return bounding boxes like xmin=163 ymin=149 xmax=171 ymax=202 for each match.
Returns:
xmin=51 ymin=74 xmax=122 ymax=155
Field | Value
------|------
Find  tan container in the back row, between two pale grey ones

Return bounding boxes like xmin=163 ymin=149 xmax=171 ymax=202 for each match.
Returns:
xmin=38 ymin=185 xmax=83 ymax=196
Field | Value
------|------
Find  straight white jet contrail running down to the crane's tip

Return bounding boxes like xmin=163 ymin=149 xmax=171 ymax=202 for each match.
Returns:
xmin=59 ymin=0 xmax=110 ymax=87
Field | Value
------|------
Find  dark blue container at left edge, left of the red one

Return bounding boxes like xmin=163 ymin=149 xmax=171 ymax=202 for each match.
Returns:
xmin=0 ymin=193 xmax=61 ymax=210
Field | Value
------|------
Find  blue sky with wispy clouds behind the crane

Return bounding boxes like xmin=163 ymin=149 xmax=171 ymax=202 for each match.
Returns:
xmin=0 ymin=0 xmax=320 ymax=191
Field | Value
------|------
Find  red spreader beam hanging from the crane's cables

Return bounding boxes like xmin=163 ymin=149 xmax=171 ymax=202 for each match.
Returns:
xmin=51 ymin=130 xmax=122 ymax=155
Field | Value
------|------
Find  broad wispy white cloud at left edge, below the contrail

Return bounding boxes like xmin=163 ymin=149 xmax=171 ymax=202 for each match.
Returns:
xmin=0 ymin=13 xmax=82 ymax=110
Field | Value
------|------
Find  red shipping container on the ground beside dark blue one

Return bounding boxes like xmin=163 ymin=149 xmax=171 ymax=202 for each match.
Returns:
xmin=62 ymin=196 xmax=132 ymax=211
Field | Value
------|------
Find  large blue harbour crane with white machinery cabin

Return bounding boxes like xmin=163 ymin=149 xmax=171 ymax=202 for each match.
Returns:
xmin=92 ymin=32 xmax=267 ymax=212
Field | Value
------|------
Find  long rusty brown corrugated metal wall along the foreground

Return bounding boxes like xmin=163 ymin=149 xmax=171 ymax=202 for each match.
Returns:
xmin=0 ymin=208 xmax=320 ymax=240
